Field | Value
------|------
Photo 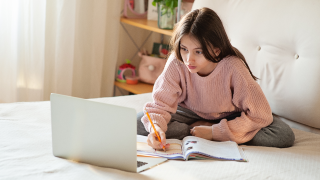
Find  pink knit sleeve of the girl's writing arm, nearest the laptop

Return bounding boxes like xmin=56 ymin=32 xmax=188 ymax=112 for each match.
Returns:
xmin=141 ymin=55 xmax=182 ymax=132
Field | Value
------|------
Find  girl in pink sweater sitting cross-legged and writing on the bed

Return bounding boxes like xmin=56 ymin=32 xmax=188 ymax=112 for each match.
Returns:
xmin=137 ymin=8 xmax=295 ymax=149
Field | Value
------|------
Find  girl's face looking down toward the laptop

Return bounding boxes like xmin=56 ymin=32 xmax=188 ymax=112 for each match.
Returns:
xmin=180 ymin=35 xmax=220 ymax=76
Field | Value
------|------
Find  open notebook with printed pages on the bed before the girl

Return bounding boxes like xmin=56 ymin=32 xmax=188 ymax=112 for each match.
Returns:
xmin=137 ymin=135 xmax=248 ymax=161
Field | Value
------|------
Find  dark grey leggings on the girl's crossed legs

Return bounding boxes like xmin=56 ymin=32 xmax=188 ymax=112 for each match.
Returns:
xmin=137 ymin=106 xmax=295 ymax=148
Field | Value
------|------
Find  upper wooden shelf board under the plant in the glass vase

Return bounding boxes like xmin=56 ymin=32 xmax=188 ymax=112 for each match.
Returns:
xmin=120 ymin=17 xmax=173 ymax=36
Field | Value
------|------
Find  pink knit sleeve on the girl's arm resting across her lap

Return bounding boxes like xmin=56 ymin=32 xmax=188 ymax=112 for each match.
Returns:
xmin=212 ymin=60 xmax=273 ymax=144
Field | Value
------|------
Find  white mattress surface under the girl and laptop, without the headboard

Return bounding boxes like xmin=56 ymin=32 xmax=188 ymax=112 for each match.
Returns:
xmin=0 ymin=94 xmax=320 ymax=180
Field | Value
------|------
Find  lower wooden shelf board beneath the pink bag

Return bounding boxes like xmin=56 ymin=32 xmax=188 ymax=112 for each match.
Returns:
xmin=114 ymin=81 xmax=153 ymax=94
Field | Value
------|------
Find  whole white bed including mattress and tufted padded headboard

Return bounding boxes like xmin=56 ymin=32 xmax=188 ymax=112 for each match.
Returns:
xmin=0 ymin=0 xmax=320 ymax=180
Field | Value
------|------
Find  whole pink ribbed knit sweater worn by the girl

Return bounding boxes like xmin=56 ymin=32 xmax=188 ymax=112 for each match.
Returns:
xmin=141 ymin=55 xmax=273 ymax=144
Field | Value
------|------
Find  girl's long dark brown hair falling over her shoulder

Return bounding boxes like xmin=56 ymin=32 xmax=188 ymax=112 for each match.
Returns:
xmin=170 ymin=7 xmax=258 ymax=80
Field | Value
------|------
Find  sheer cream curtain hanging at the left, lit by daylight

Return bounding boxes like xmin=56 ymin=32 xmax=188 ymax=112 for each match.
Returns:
xmin=0 ymin=0 xmax=121 ymax=103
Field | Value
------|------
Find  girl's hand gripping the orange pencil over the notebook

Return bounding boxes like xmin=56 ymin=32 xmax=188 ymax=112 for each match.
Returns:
xmin=148 ymin=124 xmax=170 ymax=150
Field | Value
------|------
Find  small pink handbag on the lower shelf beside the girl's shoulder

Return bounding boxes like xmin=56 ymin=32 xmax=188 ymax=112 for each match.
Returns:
xmin=138 ymin=50 xmax=167 ymax=84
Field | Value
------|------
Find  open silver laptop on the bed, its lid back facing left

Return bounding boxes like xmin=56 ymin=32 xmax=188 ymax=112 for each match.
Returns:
xmin=50 ymin=93 xmax=167 ymax=172
